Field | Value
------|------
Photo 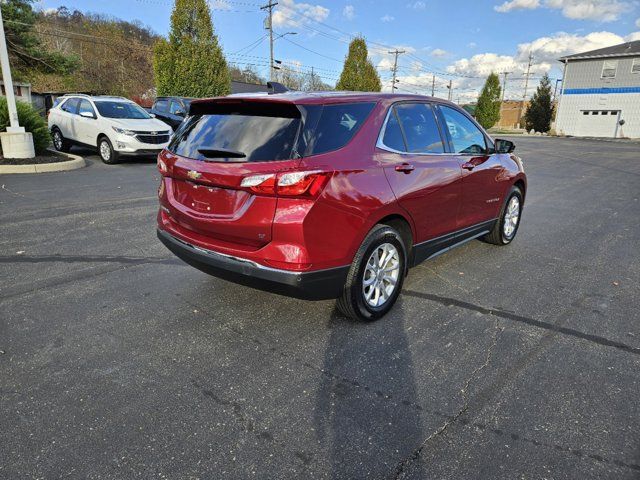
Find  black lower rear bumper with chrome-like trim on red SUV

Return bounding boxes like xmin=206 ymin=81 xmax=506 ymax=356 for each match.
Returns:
xmin=158 ymin=229 xmax=349 ymax=300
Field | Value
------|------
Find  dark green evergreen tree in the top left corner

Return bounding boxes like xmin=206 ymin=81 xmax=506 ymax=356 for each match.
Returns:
xmin=0 ymin=0 xmax=78 ymax=79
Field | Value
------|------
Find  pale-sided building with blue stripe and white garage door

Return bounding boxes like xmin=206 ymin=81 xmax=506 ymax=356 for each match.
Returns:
xmin=555 ymin=41 xmax=640 ymax=138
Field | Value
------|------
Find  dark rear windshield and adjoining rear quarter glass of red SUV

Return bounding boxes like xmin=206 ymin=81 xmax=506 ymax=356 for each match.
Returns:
xmin=168 ymin=101 xmax=375 ymax=162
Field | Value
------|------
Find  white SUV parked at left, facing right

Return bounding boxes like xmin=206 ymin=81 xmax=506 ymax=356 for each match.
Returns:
xmin=48 ymin=94 xmax=173 ymax=164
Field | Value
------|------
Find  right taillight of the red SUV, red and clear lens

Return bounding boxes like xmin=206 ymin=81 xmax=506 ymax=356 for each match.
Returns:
xmin=240 ymin=170 xmax=331 ymax=197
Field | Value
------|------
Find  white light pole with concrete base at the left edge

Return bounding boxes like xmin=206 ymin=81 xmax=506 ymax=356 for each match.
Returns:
xmin=0 ymin=4 xmax=36 ymax=158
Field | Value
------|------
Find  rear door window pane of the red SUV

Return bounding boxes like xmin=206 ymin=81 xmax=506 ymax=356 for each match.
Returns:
xmin=395 ymin=103 xmax=444 ymax=153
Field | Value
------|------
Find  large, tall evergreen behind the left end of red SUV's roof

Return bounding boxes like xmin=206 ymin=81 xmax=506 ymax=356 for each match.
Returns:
xmin=153 ymin=0 xmax=231 ymax=97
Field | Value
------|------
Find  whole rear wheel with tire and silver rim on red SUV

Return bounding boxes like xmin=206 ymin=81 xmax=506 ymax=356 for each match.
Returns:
xmin=337 ymin=225 xmax=407 ymax=320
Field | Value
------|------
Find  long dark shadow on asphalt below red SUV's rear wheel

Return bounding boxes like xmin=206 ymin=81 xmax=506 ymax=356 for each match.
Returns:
xmin=313 ymin=311 xmax=422 ymax=478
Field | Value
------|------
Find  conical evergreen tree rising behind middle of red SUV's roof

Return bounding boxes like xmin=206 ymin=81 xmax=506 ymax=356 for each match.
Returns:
xmin=336 ymin=37 xmax=382 ymax=92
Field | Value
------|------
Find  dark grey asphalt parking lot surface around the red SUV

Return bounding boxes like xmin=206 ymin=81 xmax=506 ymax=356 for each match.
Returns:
xmin=0 ymin=137 xmax=640 ymax=479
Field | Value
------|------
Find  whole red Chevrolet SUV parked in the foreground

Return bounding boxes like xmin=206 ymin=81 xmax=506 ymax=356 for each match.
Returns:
xmin=158 ymin=92 xmax=527 ymax=319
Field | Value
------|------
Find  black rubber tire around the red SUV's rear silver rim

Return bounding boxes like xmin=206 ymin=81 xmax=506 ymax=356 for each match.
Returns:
xmin=336 ymin=225 xmax=407 ymax=321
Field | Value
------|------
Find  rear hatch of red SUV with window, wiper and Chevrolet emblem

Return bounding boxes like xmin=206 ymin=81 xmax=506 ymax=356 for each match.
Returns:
xmin=159 ymin=98 xmax=305 ymax=248
